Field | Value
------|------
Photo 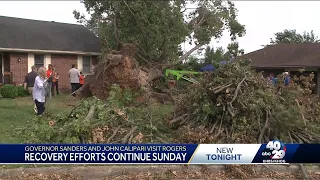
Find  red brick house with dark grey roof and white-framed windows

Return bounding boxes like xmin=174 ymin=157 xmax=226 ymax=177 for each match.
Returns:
xmin=0 ymin=16 xmax=101 ymax=89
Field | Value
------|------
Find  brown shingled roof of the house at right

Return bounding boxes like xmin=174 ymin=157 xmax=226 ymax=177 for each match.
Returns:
xmin=242 ymin=43 xmax=320 ymax=68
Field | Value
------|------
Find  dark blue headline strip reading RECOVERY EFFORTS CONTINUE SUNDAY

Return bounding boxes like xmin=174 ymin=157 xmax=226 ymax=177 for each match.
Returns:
xmin=0 ymin=144 xmax=198 ymax=164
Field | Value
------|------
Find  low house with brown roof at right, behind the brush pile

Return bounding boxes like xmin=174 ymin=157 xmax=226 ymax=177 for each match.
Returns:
xmin=242 ymin=43 xmax=320 ymax=94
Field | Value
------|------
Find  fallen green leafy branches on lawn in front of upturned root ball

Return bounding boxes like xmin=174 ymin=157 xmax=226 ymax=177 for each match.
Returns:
xmin=20 ymin=84 xmax=170 ymax=143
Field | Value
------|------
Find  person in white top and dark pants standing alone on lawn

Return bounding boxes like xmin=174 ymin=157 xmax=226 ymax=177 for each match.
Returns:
xmin=33 ymin=67 xmax=47 ymax=116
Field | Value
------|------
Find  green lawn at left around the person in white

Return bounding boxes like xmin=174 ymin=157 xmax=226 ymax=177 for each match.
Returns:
xmin=0 ymin=95 xmax=77 ymax=144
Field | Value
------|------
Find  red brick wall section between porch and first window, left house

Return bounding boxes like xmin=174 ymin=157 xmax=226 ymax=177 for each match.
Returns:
xmin=9 ymin=53 xmax=29 ymax=85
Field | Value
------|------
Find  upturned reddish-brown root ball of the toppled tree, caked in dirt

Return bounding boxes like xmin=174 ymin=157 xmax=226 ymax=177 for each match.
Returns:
xmin=81 ymin=44 xmax=148 ymax=99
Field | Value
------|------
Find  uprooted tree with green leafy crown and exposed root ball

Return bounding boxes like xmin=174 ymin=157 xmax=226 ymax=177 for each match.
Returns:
xmin=74 ymin=0 xmax=245 ymax=99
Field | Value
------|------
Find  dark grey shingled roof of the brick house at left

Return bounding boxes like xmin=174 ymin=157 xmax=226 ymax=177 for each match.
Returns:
xmin=0 ymin=16 xmax=101 ymax=53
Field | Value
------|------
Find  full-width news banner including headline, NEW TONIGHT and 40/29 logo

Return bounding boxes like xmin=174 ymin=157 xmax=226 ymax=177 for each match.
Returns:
xmin=0 ymin=140 xmax=320 ymax=164
